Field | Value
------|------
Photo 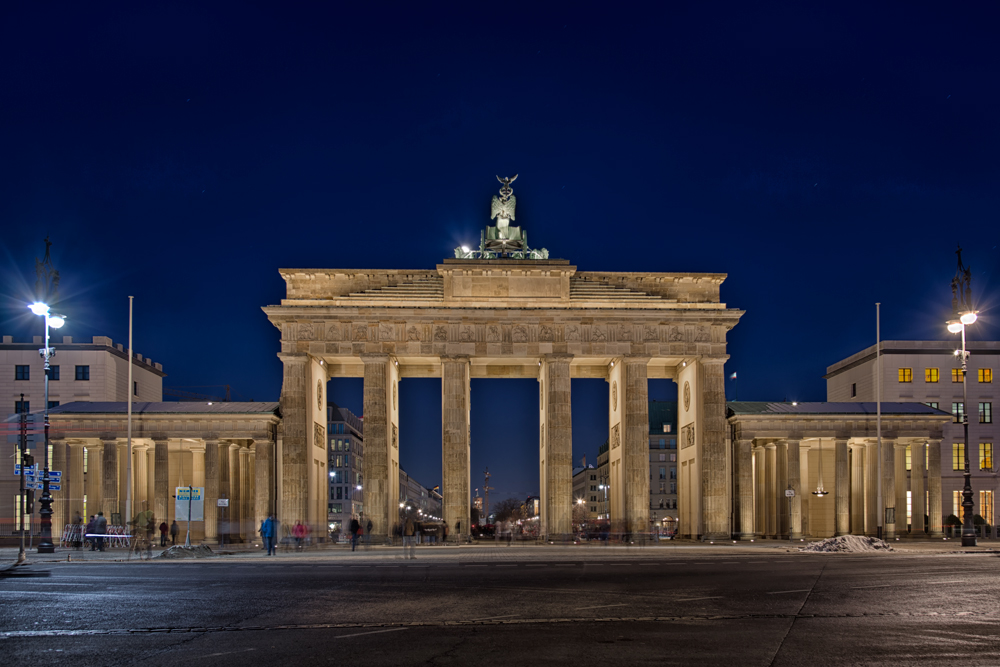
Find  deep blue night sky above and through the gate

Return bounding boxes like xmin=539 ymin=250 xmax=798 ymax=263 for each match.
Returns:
xmin=0 ymin=2 xmax=1000 ymax=496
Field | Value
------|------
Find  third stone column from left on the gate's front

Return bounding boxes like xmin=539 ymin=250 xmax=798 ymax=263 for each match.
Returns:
xmin=442 ymin=356 xmax=468 ymax=544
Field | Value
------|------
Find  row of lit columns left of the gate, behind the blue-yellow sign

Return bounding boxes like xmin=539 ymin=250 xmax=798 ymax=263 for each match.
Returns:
xmin=51 ymin=438 xmax=275 ymax=541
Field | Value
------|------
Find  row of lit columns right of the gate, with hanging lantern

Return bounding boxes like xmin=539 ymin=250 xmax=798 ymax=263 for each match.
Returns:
xmin=734 ymin=438 xmax=943 ymax=539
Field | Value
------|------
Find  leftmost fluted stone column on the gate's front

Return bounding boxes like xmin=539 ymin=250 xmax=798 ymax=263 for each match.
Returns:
xmin=278 ymin=354 xmax=308 ymax=530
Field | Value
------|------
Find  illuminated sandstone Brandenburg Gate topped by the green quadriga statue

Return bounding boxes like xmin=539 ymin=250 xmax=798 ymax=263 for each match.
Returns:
xmin=264 ymin=176 xmax=743 ymax=538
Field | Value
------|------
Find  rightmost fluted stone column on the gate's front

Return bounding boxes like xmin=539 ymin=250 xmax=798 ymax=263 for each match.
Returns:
xmin=700 ymin=357 xmax=732 ymax=539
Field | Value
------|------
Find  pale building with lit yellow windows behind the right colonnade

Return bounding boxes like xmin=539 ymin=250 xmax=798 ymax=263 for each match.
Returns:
xmin=823 ymin=340 xmax=1000 ymax=526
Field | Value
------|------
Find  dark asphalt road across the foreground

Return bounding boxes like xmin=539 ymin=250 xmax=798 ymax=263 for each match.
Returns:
xmin=0 ymin=547 xmax=1000 ymax=667
